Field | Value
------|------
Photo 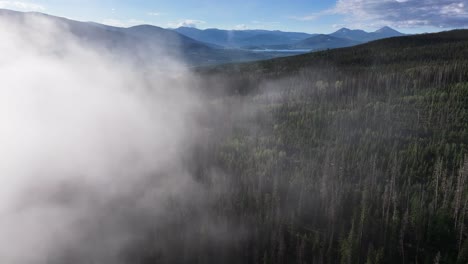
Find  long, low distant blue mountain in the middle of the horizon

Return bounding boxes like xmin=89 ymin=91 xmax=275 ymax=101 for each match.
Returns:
xmin=173 ymin=27 xmax=315 ymax=48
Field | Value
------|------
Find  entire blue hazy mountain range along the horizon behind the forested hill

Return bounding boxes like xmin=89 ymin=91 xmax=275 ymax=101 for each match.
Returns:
xmin=0 ymin=9 xmax=404 ymax=65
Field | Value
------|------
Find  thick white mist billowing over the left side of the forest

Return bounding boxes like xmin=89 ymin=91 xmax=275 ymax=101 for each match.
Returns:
xmin=0 ymin=13 xmax=215 ymax=264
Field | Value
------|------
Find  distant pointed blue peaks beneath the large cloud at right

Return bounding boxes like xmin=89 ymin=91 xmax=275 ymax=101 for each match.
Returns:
xmin=330 ymin=26 xmax=405 ymax=42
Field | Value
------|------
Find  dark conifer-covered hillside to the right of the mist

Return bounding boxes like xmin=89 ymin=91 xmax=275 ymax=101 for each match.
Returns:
xmin=124 ymin=30 xmax=468 ymax=264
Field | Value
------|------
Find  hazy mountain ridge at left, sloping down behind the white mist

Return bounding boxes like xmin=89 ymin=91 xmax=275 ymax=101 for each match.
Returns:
xmin=0 ymin=9 xmax=278 ymax=65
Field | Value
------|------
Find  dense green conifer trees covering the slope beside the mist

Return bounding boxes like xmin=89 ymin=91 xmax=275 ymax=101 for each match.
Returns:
xmin=195 ymin=31 xmax=468 ymax=263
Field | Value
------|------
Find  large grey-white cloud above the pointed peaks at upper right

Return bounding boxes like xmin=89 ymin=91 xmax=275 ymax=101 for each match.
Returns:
xmin=330 ymin=0 xmax=468 ymax=28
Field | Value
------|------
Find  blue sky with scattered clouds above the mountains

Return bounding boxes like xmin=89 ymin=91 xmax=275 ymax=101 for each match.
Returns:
xmin=0 ymin=0 xmax=468 ymax=33
